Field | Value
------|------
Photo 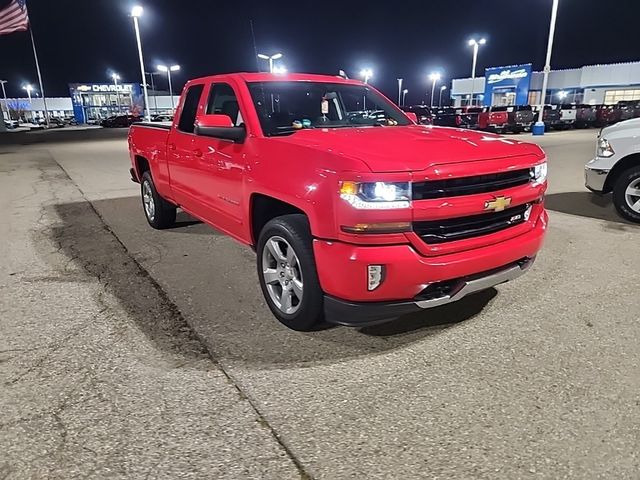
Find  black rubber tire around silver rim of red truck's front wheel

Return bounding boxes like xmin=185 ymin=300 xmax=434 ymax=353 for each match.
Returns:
xmin=256 ymin=214 xmax=324 ymax=331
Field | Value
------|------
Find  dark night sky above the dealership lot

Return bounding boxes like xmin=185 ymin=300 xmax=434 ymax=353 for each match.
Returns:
xmin=0 ymin=0 xmax=640 ymax=103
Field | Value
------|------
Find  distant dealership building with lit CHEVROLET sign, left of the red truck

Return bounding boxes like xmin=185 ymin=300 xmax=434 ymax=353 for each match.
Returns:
xmin=2 ymin=83 xmax=179 ymax=123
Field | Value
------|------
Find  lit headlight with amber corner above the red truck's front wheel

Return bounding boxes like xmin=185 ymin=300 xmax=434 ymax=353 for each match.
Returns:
xmin=340 ymin=182 xmax=411 ymax=210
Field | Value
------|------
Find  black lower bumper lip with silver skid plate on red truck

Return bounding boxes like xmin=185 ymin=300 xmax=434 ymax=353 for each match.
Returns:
xmin=324 ymin=257 xmax=535 ymax=327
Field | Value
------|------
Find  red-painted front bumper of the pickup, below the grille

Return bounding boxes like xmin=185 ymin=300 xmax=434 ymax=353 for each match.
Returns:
xmin=313 ymin=209 xmax=548 ymax=324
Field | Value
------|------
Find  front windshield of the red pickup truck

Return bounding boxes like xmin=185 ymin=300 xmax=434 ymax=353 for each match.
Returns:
xmin=249 ymin=82 xmax=411 ymax=136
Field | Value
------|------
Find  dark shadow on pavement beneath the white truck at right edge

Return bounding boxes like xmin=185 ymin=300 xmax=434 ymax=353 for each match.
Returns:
xmin=544 ymin=192 xmax=633 ymax=226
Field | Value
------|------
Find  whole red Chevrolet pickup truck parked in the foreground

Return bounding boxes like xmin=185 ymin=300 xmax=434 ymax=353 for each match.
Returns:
xmin=129 ymin=73 xmax=547 ymax=330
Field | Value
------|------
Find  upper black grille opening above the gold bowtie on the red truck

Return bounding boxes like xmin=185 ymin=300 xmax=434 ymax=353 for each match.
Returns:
xmin=412 ymin=168 xmax=531 ymax=200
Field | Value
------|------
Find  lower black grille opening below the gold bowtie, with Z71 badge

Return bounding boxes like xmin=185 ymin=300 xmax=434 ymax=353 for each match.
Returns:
xmin=413 ymin=204 xmax=531 ymax=245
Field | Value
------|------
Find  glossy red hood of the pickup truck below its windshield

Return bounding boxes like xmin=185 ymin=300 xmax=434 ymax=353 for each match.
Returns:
xmin=272 ymin=125 xmax=544 ymax=173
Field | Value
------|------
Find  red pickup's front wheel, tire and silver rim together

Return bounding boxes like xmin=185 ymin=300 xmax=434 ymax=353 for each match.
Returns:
xmin=257 ymin=214 xmax=324 ymax=331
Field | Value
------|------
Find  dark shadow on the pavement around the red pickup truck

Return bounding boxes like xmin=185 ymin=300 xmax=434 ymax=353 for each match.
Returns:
xmin=52 ymin=197 xmax=497 ymax=369
